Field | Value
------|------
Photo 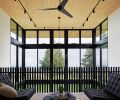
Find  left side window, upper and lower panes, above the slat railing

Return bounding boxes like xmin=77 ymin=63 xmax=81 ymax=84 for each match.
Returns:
xmin=10 ymin=20 xmax=23 ymax=67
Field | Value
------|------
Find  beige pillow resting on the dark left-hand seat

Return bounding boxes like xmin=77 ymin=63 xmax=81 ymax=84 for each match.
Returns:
xmin=0 ymin=82 xmax=17 ymax=98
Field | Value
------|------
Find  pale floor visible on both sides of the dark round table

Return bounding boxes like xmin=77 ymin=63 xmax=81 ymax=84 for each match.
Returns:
xmin=30 ymin=92 xmax=89 ymax=100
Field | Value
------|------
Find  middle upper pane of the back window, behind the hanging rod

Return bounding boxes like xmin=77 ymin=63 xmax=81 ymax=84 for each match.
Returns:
xmin=54 ymin=31 xmax=64 ymax=44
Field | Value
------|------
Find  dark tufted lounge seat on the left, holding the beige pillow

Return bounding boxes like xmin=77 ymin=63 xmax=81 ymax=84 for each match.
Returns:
xmin=0 ymin=74 xmax=35 ymax=100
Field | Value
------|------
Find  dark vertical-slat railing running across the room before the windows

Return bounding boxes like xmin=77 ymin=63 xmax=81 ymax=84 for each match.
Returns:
xmin=0 ymin=67 xmax=120 ymax=93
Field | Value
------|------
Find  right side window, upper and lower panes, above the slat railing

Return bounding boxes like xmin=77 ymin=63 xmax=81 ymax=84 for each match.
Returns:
xmin=95 ymin=19 xmax=108 ymax=67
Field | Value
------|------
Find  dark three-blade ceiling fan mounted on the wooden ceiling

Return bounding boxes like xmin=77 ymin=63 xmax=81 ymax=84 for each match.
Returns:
xmin=38 ymin=0 xmax=73 ymax=18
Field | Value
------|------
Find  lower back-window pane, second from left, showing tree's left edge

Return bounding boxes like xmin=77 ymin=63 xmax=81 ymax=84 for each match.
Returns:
xmin=38 ymin=49 xmax=50 ymax=67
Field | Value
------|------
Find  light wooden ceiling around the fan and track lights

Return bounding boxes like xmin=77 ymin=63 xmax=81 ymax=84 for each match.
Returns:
xmin=0 ymin=0 xmax=120 ymax=29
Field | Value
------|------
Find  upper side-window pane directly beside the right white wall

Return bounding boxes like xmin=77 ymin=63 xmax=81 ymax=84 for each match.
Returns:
xmin=102 ymin=20 xmax=108 ymax=39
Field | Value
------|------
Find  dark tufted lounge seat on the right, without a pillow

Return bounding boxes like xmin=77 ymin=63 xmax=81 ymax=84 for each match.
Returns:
xmin=84 ymin=73 xmax=120 ymax=100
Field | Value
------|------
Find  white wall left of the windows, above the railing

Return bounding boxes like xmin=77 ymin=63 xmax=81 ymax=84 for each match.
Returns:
xmin=0 ymin=9 xmax=10 ymax=67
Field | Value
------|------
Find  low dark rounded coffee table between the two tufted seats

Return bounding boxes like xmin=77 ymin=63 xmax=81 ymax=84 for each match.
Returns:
xmin=43 ymin=92 xmax=76 ymax=100
